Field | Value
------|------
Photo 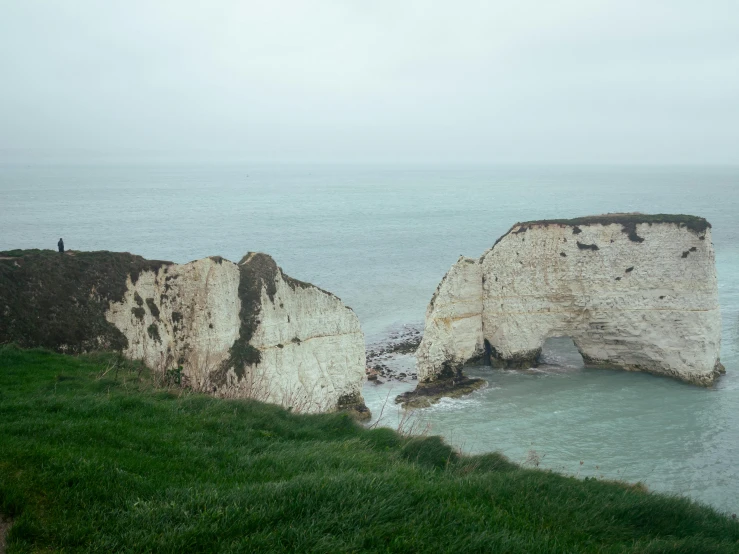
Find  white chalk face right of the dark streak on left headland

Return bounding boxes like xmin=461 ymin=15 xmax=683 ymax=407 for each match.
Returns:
xmin=222 ymin=254 xmax=366 ymax=413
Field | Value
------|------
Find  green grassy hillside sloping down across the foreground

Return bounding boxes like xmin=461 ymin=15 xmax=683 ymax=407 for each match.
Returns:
xmin=0 ymin=347 xmax=739 ymax=553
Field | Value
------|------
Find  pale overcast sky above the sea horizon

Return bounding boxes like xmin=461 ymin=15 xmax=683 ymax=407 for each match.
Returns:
xmin=0 ymin=0 xmax=739 ymax=164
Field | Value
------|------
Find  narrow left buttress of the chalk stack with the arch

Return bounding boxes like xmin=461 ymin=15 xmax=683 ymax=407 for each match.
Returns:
xmin=416 ymin=256 xmax=483 ymax=381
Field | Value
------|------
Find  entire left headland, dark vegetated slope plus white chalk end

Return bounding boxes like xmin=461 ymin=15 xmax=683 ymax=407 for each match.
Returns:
xmin=0 ymin=250 xmax=369 ymax=417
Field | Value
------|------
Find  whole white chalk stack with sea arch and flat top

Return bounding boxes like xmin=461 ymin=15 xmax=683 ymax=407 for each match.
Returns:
xmin=417 ymin=214 xmax=723 ymax=385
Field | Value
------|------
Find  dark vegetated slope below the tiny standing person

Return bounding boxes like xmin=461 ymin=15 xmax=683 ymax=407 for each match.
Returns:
xmin=0 ymin=250 xmax=171 ymax=353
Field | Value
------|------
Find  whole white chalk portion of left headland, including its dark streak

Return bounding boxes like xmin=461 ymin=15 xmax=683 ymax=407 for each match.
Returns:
xmin=106 ymin=254 xmax=366 ymax=413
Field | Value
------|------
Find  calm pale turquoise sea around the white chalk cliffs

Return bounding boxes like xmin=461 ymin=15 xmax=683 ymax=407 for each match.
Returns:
xmin=0 ymin=165 xmax=739 ymax=512
